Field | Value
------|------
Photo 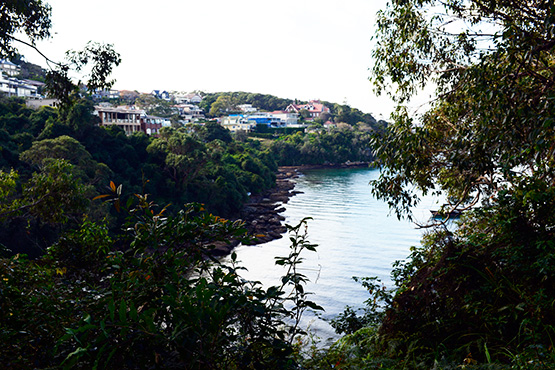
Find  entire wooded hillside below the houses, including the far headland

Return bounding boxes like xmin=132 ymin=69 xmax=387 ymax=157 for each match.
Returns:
xmin=0 ymin=98 xmax=378 ymax=256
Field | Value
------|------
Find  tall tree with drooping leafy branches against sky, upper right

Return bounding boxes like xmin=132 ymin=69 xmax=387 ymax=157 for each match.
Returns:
xmin=373 ymin=0 xmax=555 ymax=217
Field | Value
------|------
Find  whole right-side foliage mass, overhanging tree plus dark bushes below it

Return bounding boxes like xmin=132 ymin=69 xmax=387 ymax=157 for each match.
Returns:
xmin=312 ymin=0 xmax=555 ymax=369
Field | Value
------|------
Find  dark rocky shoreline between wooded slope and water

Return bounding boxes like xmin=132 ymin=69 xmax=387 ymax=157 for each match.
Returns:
xmin=213 ymin=162 xmax=369 ymax=256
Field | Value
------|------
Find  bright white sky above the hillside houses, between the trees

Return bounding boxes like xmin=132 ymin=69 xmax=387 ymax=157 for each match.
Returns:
xmin=20 ymin=0 xmax=400 ymax=118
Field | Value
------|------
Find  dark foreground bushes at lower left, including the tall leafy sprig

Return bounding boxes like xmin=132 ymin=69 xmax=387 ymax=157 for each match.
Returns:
xmin=0 ymin=184 xmax=320 ymax=369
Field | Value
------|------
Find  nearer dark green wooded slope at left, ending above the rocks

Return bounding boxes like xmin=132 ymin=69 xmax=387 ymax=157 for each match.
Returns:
xmin=0 ymin=98 xmax=277 ymax=255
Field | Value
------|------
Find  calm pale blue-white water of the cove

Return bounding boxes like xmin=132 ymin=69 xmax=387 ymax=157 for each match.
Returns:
xmin=232 ymin=169 xmax=437 ymax=339
